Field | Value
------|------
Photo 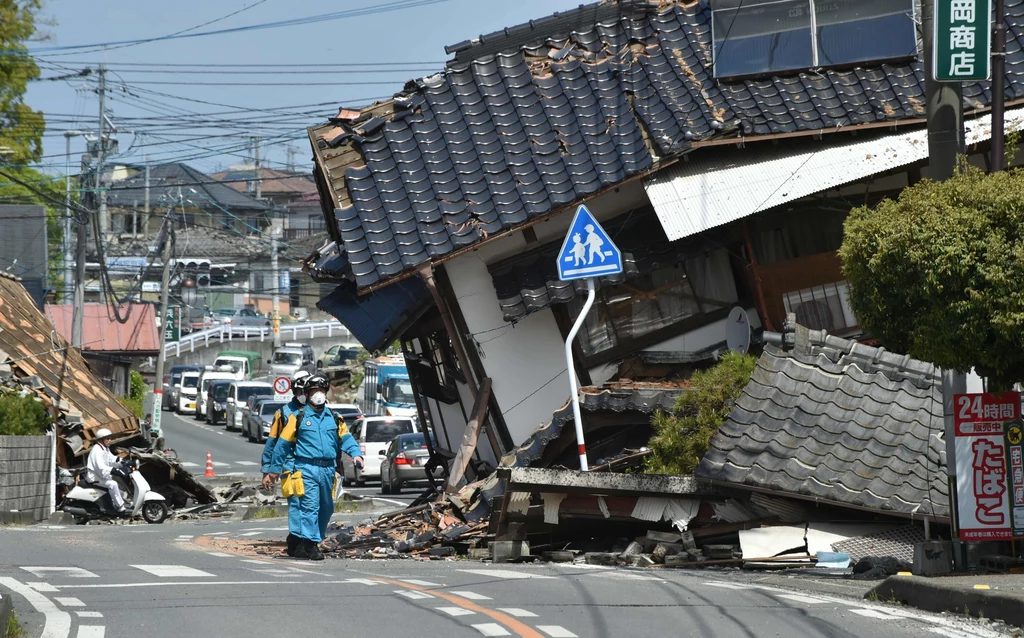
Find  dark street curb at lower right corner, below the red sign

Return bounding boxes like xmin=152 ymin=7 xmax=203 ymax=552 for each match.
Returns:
xmin=864 ymin=576 xmax=1024 ymax=627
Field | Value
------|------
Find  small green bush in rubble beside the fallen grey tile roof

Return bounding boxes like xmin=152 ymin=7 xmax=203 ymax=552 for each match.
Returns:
xmin=646 ymin=352 xmax=758 ymax=474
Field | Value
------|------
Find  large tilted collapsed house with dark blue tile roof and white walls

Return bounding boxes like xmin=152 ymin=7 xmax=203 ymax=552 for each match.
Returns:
xmin=305 ymin=0 xmax=1024 ymax=490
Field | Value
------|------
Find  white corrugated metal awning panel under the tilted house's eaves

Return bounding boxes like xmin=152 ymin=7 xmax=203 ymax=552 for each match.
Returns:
xmin=644 ymin=109 xmax=1024 ymax=241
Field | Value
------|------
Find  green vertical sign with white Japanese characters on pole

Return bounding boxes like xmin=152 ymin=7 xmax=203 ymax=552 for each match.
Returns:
xmin=932 ymin=0 xmax=992 ymax=82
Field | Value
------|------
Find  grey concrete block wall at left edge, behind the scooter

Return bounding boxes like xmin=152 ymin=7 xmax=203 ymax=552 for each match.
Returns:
xmin=0 ymin=436 xmax=51 ymax=520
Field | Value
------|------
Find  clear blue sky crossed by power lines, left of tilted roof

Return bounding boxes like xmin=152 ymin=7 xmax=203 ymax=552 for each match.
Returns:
xmin=26 ymin=0 xmax=580 ymax=175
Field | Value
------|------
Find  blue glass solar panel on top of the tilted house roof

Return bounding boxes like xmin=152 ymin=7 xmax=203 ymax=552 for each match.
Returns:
xmin=712 ymin=0 xmax=918 ymax=78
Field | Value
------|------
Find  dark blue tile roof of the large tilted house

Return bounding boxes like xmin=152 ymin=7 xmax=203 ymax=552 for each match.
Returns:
xmin=309 ymin=0 xmax=1024 ymax=290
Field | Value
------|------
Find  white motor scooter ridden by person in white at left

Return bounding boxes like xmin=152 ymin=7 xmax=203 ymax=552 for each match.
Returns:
xmin=59 ymin=459 xmax=170 ymax=524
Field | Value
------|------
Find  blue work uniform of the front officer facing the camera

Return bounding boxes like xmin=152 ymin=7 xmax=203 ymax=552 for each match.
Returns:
xmin=270 ymin=406 xmax=361 ymax=543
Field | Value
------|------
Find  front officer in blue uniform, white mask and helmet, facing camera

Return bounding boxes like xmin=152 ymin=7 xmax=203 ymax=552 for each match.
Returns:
xmin=267 ymin=375 xmax=362 ymax=560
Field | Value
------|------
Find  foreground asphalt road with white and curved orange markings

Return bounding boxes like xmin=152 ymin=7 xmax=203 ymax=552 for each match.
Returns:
xmin=0 ymin=519 xmax=1005 ymax=638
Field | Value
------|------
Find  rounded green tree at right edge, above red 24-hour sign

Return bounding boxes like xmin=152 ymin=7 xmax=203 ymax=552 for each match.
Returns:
xmin=840 ymin=163 xmax=1024 ymax=389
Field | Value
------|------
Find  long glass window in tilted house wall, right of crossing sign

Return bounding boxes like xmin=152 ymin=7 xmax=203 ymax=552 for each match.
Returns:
xmin=569 ymin=250 xmax=738 ymax=356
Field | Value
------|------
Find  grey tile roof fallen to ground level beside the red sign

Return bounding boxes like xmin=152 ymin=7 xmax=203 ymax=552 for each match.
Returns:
xmin=694 ymin=326 xmax=949 ymax=519
